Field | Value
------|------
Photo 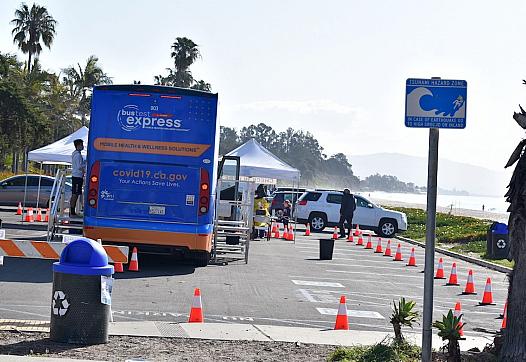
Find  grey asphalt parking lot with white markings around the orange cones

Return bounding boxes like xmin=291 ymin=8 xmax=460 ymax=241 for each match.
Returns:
xmin=0 ymin=225 xmax=508 ymax=335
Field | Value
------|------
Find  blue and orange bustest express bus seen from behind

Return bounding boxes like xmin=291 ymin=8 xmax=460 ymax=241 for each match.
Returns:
xmin=84 ymin=85 xmax=219 ymax=265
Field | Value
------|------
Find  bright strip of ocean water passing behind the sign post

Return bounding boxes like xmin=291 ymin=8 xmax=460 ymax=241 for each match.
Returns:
xmin=361 ymin=191 xmax=509 ymax=213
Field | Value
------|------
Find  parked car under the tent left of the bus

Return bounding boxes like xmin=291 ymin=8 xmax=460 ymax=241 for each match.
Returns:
xmin=0 ymin=174 xmax=71 ymax=207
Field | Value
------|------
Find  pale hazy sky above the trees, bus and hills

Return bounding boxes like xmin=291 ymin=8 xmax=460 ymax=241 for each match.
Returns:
xmin=0 ymin=0 xmax=526 ymax=177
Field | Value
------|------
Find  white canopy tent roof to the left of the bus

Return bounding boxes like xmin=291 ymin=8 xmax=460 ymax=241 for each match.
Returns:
xmin=28 ymin=126 xmax=89 ymax=165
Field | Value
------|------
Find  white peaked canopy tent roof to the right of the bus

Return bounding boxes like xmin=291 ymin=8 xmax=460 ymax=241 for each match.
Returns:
xmin=227 ymin=139 xmax=300 ymax=183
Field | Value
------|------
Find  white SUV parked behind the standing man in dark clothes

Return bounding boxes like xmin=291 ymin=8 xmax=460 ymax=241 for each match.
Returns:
xmin=295 ymin=190 xmax=407 ymax=237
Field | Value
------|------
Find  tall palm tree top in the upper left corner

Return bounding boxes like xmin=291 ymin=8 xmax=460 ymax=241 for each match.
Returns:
xmin=11 ymin=4 xmax=57 ymax=73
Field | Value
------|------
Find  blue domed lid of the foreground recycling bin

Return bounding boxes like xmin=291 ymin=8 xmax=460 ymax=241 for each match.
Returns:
xmin=53 ymin=237 xmax=113 ymax=275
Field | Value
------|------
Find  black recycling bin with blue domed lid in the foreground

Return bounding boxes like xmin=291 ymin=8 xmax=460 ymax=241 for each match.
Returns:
xmin=50 ymin=237 xmax=113 ymax=344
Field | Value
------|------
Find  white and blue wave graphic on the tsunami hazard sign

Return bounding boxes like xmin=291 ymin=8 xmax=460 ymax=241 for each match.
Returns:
xmin=406 ymin=87 xmax=466 ymax=118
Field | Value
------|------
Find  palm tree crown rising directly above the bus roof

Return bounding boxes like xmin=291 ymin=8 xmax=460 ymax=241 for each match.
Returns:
xmin=171 ymin=37 xmax=201 ymax=88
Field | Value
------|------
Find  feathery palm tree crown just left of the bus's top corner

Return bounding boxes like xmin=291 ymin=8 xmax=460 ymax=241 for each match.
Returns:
xmin=62 ymin=55 xmax=112 ymax=125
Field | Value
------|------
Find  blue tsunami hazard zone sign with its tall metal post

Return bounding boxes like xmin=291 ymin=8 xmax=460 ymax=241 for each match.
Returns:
xmin=405 ymin=78 xmax=467 ymax=362
